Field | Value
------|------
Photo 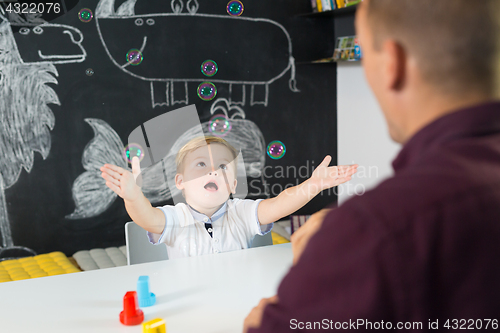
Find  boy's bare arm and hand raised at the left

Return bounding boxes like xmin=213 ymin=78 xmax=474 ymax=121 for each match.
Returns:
xmin=101 ymin=157 xmax=165 ymax=234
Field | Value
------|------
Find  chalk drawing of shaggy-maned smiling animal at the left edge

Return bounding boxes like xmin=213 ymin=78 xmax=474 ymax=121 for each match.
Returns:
xmin=0 ymin=10 xmax=86 ymax=261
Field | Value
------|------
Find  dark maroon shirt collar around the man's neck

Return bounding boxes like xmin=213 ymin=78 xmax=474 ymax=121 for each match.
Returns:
xmin=392 ymin=102 xmax=500 ymax=173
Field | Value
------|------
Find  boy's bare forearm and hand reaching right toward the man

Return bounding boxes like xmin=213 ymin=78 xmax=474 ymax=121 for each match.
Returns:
xmin=257 ymin=156 xmax=358 ymax=224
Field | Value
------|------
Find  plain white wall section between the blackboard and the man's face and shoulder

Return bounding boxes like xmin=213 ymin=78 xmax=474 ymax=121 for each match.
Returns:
xmin=337 ymin=62 xmax=400 ymax=205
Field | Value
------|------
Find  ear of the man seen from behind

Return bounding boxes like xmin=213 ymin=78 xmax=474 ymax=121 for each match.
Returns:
xmin=382 ymin=39 xmax=408 ymax=91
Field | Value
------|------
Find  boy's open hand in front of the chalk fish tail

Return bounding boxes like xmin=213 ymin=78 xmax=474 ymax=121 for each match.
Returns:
xmin=100 ymin=157 xmax=141 ymax=201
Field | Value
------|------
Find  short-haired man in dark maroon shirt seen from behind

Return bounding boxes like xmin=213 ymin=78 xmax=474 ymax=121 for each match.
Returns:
xmin=245 ymin=0 xmax=500 ymax=333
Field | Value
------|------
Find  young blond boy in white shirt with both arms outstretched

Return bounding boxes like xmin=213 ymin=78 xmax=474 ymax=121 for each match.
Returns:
xmin=101 ymin=137 xmax=357 ymax=259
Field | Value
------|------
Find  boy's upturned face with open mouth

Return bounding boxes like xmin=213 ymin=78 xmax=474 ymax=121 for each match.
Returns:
xmin=175 ymin=143 xmax=237 ymax=209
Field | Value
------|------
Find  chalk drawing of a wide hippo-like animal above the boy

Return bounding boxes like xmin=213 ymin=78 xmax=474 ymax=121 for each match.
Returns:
xmin=95 ymin=0 xmax=299 ymax=108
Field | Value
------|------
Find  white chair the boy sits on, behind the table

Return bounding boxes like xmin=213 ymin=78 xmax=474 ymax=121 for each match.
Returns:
xmin=125 ymin=222 xmax=273 ymax=265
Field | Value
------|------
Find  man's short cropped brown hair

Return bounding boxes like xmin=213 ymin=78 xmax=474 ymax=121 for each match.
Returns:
xmin=367 ymin=0 xmax=500 ymax=97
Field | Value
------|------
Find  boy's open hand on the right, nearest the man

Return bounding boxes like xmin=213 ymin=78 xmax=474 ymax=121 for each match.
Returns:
xmin=309 ymin=155 xmax=358 ymax=191
